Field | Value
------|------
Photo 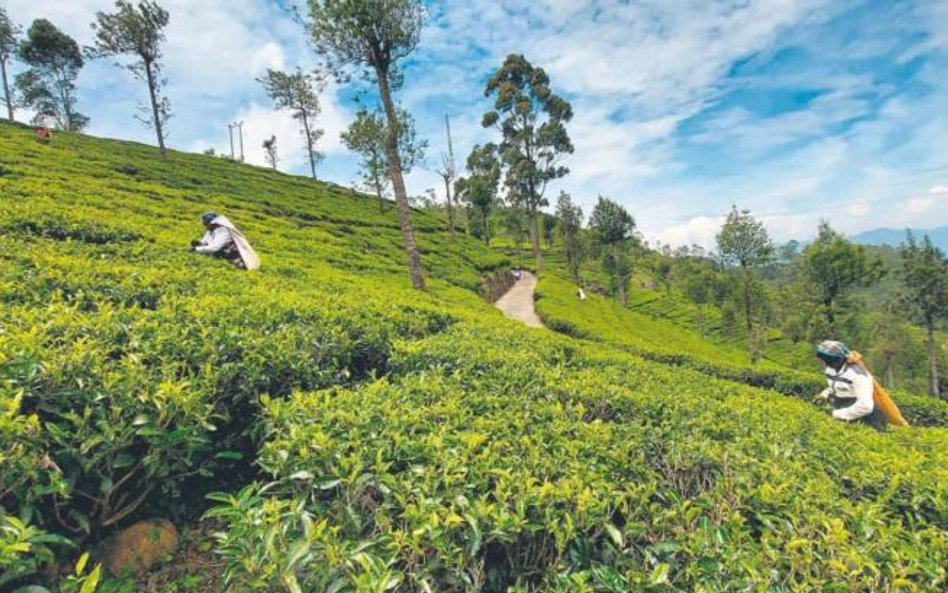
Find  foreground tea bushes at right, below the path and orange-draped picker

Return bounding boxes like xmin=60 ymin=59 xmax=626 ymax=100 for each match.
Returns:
xmin=210 ymin=323 xmax=948 ymax=592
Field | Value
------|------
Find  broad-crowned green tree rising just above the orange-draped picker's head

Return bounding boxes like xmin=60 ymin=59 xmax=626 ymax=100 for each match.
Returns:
xmin=802 ymin=220 xmax=885 ymax=337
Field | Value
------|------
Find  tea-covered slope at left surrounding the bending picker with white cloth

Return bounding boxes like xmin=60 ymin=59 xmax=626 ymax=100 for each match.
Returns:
xmin=0 ymin=124 xmax=507 ymax=590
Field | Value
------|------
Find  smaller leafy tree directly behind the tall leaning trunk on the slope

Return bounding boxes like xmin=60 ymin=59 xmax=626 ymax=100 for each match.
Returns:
xmin=341 ymin=107 xmax=428 ymax=211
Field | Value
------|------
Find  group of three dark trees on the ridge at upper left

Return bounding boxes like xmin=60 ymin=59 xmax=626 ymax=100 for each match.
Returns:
xmin=0 ymin=0 xmax=171 ymax=153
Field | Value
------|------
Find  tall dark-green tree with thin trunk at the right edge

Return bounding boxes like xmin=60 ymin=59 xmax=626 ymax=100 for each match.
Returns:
xmin=899 ymin=233 xmax=948 ymax=397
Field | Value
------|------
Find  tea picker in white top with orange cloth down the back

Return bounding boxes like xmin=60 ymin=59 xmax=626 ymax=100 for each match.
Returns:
xmin=816 ymin=340 xmax=908 ymax=428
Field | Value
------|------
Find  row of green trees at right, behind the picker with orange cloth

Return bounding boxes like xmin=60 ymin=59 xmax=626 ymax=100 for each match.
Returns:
xmin=712 ymin=207 xmax=948 ymax=396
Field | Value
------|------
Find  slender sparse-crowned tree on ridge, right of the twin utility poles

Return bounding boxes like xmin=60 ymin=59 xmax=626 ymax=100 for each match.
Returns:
xmin=257 ymin=68 xmax=323 ymax=179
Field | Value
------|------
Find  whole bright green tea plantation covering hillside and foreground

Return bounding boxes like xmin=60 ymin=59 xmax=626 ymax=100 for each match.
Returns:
xmin=0 ymin=124 xmax=948 ymax=593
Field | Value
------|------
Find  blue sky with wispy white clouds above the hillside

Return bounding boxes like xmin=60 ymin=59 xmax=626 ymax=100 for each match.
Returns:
xmin=7 ymin=0 xmax=948 ymax=246
